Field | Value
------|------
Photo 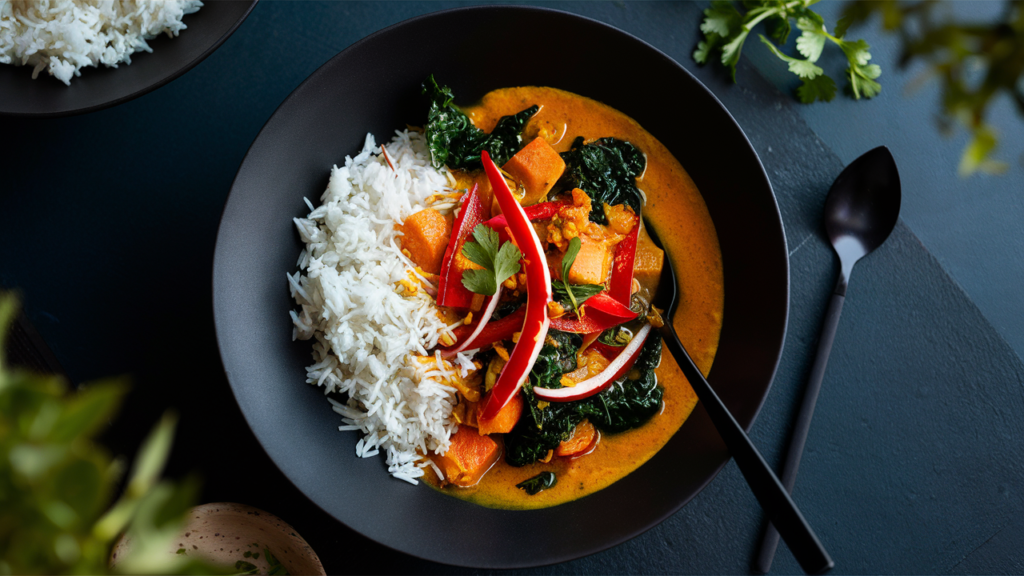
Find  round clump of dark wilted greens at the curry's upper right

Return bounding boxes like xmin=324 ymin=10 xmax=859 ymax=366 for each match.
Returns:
xmin=561 ymin=136 xmax=647 ymax=224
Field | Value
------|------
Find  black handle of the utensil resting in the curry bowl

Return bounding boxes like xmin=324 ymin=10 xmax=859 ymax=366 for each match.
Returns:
xmin=662 ymin=323 xmax=834 ymax=574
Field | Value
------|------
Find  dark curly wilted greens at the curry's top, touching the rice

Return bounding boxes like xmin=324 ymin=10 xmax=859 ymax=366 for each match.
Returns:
xmin=423 ymin=75 xmax=541 ymax=169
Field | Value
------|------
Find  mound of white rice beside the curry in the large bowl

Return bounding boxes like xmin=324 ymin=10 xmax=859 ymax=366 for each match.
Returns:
xmin=288 ymin=130 xmax=471 ymax=484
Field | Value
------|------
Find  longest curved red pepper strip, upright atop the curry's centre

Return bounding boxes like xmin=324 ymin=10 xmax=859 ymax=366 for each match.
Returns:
xmin=479 ymin=151 xmax=551 ymax=420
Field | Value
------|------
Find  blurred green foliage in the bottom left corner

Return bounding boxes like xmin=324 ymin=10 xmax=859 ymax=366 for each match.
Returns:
xmin=0 ymin=293 xmax=206 ymax=574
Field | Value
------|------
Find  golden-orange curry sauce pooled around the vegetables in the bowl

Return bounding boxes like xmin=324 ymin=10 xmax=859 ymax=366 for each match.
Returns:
xmin=426 ymin=87 xmax=724 ymax=509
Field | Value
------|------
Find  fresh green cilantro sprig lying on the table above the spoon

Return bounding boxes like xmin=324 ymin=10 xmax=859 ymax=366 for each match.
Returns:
xmin=693 ymin=0 xmax=882 ymax=104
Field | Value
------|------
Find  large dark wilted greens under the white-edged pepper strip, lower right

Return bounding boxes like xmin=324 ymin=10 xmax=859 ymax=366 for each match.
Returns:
xmin=505 ymin=330 xmax=664 ymax=466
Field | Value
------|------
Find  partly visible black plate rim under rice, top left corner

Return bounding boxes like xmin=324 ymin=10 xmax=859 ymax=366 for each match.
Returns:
xmin=0 ymin=0 xmax=257 ymax=117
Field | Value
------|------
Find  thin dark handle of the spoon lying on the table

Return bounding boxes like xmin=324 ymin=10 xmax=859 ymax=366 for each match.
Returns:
xmin=755 ymin=275 xmax=846 ymax=574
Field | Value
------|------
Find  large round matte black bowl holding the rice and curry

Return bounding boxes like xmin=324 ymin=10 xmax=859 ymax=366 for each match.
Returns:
xmin=213 ymin=7 xmax=790 ymax=568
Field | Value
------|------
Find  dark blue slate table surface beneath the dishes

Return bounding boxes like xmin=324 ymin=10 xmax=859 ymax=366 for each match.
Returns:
xmin=0 ymin=0 xmax=1024 ymax=574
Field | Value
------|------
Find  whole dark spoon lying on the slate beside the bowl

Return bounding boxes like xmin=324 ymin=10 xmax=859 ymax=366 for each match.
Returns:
xmin=755 ymin=146 xmax=900 ymax=574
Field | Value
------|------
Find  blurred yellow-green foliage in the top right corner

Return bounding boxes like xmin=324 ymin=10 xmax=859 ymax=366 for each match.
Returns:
xmin=844 ymin=0 xmax=1024 ymax=176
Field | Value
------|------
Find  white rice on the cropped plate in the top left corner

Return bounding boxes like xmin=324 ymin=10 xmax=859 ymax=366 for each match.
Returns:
xmin=0 ymin=0 xmax=203 ymax=86
